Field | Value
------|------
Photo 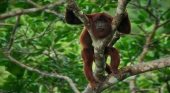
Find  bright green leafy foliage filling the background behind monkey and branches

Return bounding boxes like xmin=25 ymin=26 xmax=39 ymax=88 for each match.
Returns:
xmin=0 ymin=0 xmax=170 ymax=93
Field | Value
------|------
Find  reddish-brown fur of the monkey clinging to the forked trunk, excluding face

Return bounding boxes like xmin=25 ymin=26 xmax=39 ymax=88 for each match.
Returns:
xmin=66 ymin=9 xmax=131 ymax=88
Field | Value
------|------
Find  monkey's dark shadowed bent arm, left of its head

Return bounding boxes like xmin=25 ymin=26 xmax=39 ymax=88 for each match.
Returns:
xmin=65 ymin=8 xmax=82 ymax=25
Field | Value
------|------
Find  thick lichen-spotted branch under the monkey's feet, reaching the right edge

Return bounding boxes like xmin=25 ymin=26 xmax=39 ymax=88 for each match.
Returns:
xmin=83 ymin=57 xmax=170 ymax=93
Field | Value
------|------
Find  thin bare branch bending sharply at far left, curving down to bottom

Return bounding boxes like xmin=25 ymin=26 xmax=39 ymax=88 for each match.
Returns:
xmin=3 ymin=3 xmax=80 ymax=93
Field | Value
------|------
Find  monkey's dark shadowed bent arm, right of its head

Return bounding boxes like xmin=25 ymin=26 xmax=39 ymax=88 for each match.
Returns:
xmin=117 ymin=12 xmax=131 ymax=34
